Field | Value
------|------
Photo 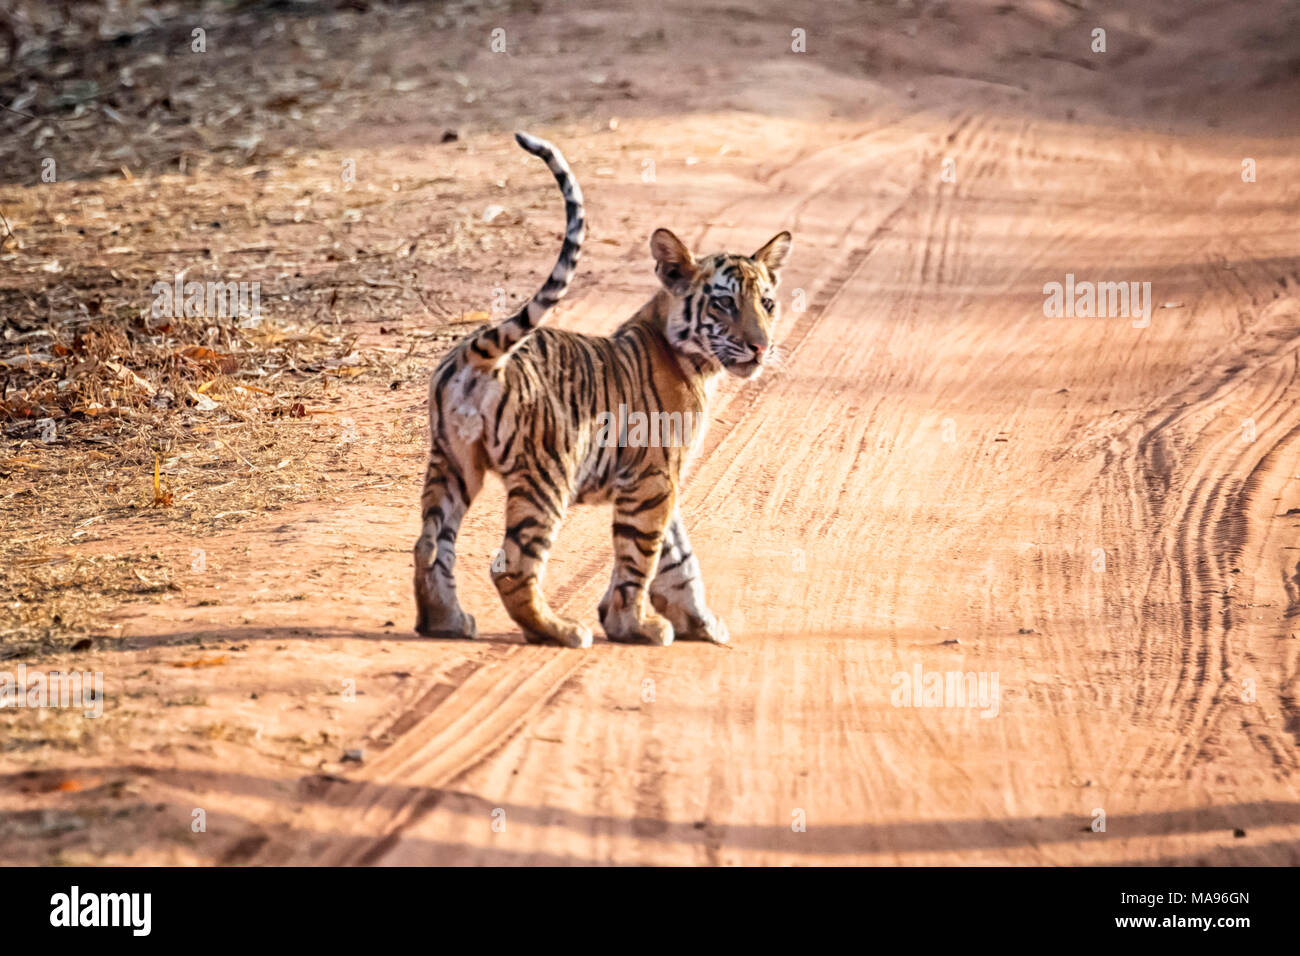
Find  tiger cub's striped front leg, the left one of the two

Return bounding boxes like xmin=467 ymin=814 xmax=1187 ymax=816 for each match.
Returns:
xmin=601 ymin=472 xmax=676 ymax=646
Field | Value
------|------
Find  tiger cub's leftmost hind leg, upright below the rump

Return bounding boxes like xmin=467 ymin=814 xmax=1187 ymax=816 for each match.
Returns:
xmin=415 ymin=449 xmax=484 ymax=637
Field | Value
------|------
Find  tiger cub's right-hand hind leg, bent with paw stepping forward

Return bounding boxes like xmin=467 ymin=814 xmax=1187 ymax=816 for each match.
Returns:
xmin=491 ymin=481 xmax=592 ymax=648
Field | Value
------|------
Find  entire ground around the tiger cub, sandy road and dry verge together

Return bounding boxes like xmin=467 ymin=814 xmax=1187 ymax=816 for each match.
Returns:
xmin=0 ymin=1 xmax=1300 ymax=864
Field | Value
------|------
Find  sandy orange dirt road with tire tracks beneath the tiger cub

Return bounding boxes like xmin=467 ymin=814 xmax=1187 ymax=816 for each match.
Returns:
xmin=7 ymin=4 xmax=1300 ymax=865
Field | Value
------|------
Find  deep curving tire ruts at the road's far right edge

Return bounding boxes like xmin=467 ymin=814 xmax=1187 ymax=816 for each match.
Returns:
xmin=1112 ymin=316 xmax=1300 ymax=775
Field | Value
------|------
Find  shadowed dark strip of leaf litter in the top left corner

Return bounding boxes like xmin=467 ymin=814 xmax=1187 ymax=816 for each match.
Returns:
xmin=0 ymin=0 xmax=507 ymax=183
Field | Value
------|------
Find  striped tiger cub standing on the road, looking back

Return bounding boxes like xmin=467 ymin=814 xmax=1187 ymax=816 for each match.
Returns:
xmin=415 ymin=133 xmax=790 ymax=648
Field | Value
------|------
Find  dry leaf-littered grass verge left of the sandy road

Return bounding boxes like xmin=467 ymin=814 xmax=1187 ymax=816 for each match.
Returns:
xmin=0 ymin=1 xmax=592 ymax=659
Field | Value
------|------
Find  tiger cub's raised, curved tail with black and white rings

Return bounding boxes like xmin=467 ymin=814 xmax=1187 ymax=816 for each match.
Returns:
xmin=469 ymin=133 xmax=586 ymax=368
